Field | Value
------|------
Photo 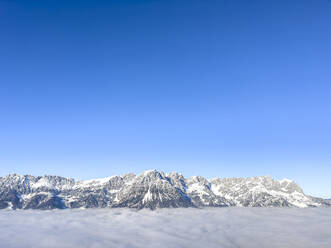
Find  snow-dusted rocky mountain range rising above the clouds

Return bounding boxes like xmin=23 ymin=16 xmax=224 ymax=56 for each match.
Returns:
xmin=0 ymin=170 xmax=331 ymax=209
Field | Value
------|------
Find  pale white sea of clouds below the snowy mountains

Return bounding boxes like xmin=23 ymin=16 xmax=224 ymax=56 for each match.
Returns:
xmin=0 ymin=208 xmax=331 ymax=248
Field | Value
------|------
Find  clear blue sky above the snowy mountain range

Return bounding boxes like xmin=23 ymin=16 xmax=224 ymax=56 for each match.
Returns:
xmin=0 ymin=0 xmax=331 ymax=198
